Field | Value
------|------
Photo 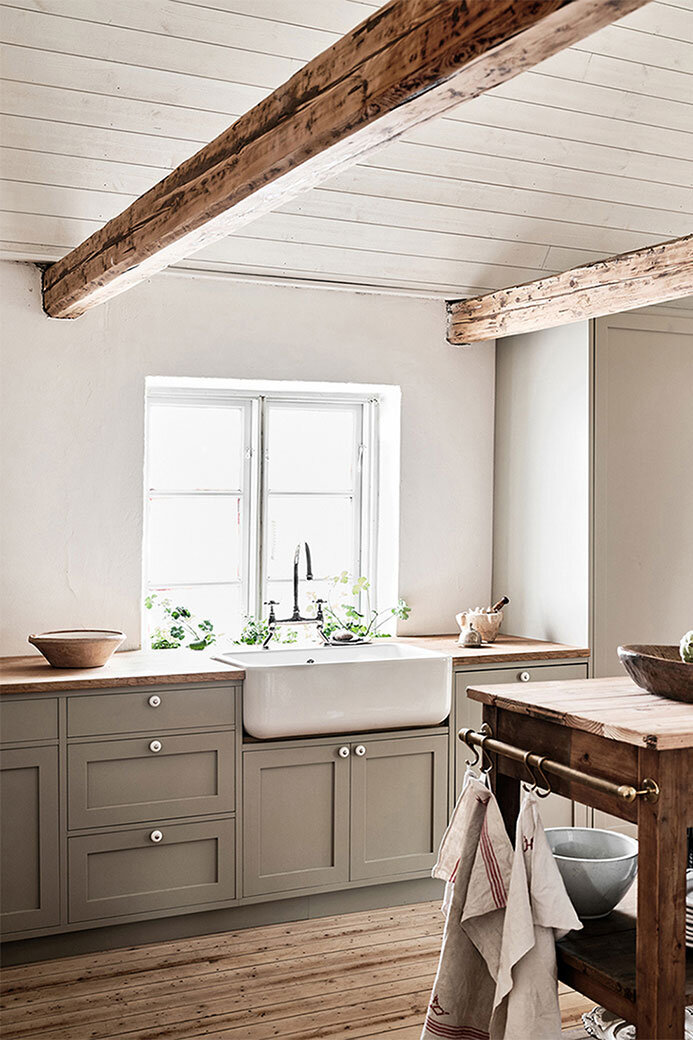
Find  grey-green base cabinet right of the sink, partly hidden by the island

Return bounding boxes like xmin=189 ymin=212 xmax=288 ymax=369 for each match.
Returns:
xmin=455 ymin=665 xmax=587 ymax=827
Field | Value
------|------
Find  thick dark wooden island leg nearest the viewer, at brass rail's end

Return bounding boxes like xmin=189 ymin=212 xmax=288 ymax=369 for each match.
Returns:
xmin=636 ymin=750 xmax=687 ymax=1040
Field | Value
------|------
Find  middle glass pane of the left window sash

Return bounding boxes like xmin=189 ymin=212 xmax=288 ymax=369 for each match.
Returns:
xmin=147 ymin=495 xmax=242 ymax=584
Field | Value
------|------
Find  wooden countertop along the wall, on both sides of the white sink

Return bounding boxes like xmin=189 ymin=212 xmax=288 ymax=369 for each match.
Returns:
xmin=0 ymin=635 xmax=589 ymax=694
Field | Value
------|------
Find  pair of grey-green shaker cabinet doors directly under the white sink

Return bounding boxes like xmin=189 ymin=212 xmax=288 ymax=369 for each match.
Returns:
xmin=242 ymin=733 xmax=447 ymax=895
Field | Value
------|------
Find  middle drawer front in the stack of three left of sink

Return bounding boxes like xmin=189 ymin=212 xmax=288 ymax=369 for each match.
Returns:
xmin=68 ymin=730 xmax=235 ymax=830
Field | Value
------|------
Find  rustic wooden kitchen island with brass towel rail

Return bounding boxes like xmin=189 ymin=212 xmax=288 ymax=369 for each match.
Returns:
xmin=468 ymin=678 xmax=693 ymax=1040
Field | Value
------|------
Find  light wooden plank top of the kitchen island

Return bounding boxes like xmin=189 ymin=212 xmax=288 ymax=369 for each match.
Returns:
xmin=467 ymin=676 xmax=693 ymax=751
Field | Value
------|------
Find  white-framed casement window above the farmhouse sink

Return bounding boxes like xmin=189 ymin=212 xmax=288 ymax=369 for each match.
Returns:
xmin=144 ymin=379 xmax=399 ymax=639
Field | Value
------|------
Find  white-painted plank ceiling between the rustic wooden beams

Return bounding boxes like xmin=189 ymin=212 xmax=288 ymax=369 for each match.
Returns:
xmin=0 ymin=0 xmax=693 ymax=297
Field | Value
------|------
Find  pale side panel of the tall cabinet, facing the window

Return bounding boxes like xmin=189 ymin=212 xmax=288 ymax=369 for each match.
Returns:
xmin=493 ymin=321 xmax=590 ymax=646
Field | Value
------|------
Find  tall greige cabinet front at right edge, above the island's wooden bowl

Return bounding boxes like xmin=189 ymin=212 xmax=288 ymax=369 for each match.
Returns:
xmin=592 ymin=302 xmax=693 ymax=676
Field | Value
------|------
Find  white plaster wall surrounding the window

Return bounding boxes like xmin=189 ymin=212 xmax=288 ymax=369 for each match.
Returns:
xmin=0 ymin=262 xmax=494 ymax=654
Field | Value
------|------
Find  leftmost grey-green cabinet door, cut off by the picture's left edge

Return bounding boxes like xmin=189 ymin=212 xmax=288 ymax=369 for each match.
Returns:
xmin=0 ymin=748 xmax=60 ymax=933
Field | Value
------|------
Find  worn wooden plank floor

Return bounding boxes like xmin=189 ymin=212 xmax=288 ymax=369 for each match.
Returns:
xmin=0 ymin=903 xmax=592 ymax=1040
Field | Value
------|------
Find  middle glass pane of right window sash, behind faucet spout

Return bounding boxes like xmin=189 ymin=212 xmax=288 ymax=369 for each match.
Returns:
xmin=265 ymin=495 xmax=356 ymax=582
